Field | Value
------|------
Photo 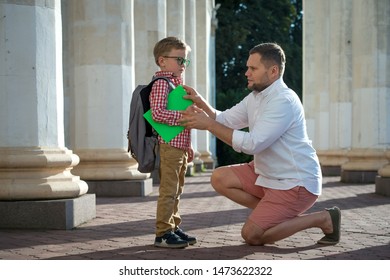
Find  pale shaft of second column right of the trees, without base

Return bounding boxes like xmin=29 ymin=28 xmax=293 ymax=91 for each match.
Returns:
xmin=328 ymin=0 xmax=353 ymax=153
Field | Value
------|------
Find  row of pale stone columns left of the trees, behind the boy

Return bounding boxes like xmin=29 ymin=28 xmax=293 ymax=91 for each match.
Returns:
xmin=0 ymin=0 xmax=215 ymax=228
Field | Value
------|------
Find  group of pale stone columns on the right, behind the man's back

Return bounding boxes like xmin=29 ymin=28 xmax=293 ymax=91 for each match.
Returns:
xmin=303 ymin=0 xmax=390 ymax=182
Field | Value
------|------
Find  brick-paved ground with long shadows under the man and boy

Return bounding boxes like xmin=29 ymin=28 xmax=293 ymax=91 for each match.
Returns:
xmin=0 ymin=172 xmax=390 ymax=260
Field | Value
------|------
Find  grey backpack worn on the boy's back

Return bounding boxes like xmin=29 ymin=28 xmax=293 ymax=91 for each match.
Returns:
xmin=127 ymin=77 xmax=175 ymax=173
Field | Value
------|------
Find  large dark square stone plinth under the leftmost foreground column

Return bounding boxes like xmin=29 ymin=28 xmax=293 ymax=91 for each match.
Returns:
xmin=0 ymin=194 xmax=96 ymax=230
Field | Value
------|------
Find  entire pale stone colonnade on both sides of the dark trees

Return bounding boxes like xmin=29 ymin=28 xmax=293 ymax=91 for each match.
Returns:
xmin=0 ymin=0 xmax=390 ymax=229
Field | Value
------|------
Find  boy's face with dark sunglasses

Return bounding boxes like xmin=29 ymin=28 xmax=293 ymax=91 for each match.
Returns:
xmin=159 ymin=49 xmax=187 ymax=77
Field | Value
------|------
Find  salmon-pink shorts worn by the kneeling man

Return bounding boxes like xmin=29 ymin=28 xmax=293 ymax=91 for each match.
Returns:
xmin=230 ymin=161 xmax=318 ymax=230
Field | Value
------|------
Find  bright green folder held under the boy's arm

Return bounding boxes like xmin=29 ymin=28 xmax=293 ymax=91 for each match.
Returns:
xmin=144 ymin=85 xmax=193 ymax=143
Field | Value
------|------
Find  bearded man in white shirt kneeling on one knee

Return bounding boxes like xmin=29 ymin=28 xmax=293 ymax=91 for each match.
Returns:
xmin=181 ymin=43 xmax=341 ymax=245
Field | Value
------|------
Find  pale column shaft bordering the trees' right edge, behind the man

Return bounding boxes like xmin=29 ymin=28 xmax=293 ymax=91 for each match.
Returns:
xmin=302 ymin=0 xmax=329 ymax=150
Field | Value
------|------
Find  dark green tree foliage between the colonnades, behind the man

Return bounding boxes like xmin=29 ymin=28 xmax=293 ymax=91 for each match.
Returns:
xmin=216 ymin=0 xmax=302 ymax=165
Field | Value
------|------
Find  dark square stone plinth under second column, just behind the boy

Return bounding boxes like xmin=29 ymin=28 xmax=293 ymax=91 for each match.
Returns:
xmin=86 ymin=178 xmax=153 ymax=197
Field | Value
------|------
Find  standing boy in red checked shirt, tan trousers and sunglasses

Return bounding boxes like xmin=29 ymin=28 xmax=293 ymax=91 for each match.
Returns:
xmin=149 ymin=37 xmax=196 ymax=248
